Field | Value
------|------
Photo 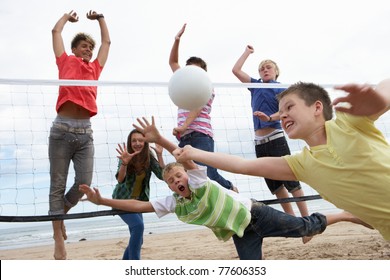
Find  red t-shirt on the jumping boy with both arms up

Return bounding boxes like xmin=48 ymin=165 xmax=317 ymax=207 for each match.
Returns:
xmin=56 ymin=52 xmax=103 ymax=117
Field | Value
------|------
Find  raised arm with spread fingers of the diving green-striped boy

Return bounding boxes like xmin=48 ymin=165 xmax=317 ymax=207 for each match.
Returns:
xmin=133 ymin=116 xmax=197 ymax=169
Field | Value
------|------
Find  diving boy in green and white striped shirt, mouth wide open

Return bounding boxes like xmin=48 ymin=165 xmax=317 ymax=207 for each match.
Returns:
xmin=80 ymin=117 xmax=368 ymax=260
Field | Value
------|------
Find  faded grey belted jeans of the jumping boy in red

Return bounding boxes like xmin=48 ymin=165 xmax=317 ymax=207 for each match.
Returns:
xmin=49 ymin=117 xmax=95 ymax=215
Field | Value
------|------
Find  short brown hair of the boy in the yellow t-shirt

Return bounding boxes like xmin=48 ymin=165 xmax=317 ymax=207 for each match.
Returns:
xmin=277 ymin=82 xmax=333 ymax=121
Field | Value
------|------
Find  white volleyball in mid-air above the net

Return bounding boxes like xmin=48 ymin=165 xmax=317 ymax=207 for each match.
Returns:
xmin=168 ymin=65 xmax=213 ymax=110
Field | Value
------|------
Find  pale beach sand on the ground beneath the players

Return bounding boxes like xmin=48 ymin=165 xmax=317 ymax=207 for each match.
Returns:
xmin=0 ymin=222 xmax=390 ymax=260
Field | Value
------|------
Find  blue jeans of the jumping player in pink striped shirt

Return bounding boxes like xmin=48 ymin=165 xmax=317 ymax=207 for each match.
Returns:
xmin=179 ymin=131 xmax=233 ymax=190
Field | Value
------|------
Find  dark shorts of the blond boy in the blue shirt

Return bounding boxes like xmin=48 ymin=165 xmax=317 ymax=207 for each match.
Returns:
xmin=255 ymin=137 xmax=301 ymax=194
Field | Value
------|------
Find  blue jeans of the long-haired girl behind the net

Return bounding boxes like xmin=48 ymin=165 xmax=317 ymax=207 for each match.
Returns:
xmin=119 ymin=213 xmax=144 ymax=260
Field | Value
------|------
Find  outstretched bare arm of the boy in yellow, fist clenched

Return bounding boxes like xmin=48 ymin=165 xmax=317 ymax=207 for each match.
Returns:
xmin=174 ymin=145 xmax=296 ymax=181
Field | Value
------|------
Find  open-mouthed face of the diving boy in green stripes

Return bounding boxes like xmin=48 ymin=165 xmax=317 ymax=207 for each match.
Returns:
xmin=163 ymin=163 xmax=191 ymax=198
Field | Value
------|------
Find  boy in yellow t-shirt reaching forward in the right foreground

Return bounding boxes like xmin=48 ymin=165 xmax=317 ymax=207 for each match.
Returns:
xmin=174 ymin=79 xmax=390 ymax=240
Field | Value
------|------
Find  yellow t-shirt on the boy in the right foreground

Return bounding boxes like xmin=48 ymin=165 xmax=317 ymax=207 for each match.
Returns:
xmin=284 ymin=113 xmax=390 ymax=240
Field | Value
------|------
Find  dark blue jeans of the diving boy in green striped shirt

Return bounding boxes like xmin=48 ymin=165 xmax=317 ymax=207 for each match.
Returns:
xmin=233 ymin=202 xmax=327 ymax=260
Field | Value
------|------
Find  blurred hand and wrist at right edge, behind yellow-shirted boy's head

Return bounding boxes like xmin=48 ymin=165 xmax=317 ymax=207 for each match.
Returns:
xmin=332 ymin=79 xmax=390 ymax=120
